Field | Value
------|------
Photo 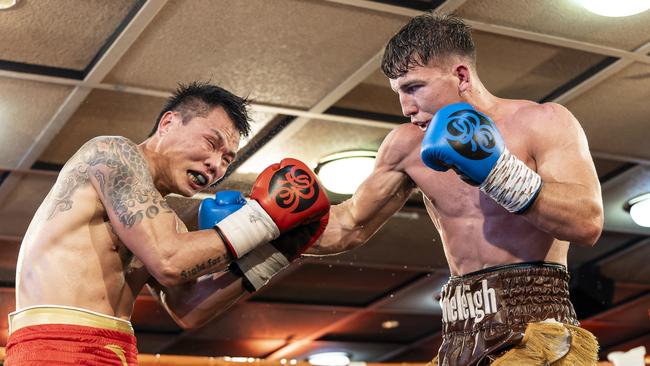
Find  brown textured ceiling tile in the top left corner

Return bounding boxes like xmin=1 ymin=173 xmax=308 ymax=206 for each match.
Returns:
xmin=0 ymin=0 xmax=137 ymax=70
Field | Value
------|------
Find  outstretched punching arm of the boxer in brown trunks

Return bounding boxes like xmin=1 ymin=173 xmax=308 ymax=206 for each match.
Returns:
xmin=307 ymin=128 xmax=419 ymax=255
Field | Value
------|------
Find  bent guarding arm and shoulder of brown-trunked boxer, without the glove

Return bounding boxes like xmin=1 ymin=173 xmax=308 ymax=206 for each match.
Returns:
xmin=521 ymin=103 xmax=603 ymax=245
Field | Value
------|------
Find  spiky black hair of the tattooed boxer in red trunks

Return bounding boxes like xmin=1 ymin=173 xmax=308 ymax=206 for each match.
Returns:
xmin=149 ymin=81 xmax=251 ymax=137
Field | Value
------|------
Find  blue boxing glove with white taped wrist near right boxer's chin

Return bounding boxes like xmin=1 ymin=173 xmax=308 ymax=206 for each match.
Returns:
xmin=420 ymin=103 xmax=542 ymax=213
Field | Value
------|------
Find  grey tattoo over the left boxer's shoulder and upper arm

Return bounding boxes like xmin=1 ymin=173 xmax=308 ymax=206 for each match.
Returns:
xmin=50 ymin=137 xmax=171 ymax=228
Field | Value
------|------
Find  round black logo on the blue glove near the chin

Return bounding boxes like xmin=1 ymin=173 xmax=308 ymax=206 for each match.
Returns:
xmin=447 ymin=109 xmax=496 ymax=160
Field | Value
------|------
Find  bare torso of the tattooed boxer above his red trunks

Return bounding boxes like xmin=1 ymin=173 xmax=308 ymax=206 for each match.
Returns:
xmin=16 ymin=144 xmax=176 ymax=320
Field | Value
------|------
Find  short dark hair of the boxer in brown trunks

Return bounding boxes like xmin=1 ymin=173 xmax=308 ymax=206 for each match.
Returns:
xmin=381 ymin=13 xmax=476 ymax=79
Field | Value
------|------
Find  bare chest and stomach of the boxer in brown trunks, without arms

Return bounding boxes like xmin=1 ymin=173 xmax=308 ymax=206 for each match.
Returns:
xmin=391 ymin=101 xmax=568 ymax=275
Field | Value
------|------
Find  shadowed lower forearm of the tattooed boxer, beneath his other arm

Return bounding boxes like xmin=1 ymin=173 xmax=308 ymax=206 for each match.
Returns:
xmin=160 ymin=272 xmax=246 ymax=329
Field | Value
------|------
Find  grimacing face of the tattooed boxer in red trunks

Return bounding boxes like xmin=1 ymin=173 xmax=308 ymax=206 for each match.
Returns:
xmin=159 ymin=107 xmax=240 ymax=197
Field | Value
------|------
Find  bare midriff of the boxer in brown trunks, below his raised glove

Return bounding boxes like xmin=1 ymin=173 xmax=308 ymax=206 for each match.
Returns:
xmin=409 ymin=164 xmax=568 ymax=275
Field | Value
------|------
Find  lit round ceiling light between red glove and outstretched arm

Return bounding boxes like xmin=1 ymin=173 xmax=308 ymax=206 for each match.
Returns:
xmin=315 ymin=150 xmax=377 ymax=194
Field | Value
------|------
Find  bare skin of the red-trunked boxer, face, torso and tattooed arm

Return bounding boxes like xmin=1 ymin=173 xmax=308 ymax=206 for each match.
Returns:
xmin=16 ymin=107 xmax=243 ymax=326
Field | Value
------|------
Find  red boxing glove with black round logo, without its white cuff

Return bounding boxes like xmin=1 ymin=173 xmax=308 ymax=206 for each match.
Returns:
xmin=250 ymin=158 xmax=330 ymax=232
